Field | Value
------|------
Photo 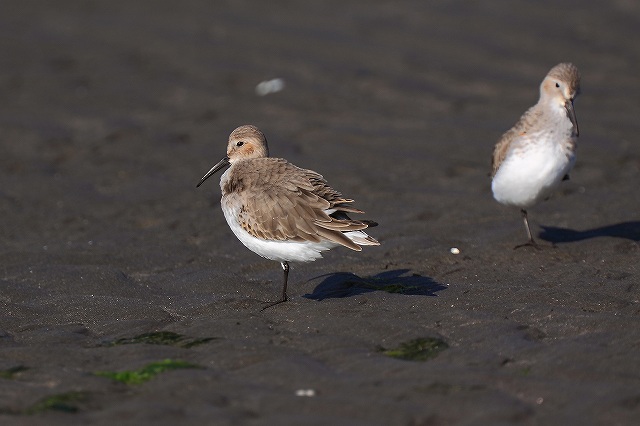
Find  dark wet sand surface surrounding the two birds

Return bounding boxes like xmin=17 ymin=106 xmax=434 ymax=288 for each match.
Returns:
xmin=0 ymin=0 xmax=640 ymax=425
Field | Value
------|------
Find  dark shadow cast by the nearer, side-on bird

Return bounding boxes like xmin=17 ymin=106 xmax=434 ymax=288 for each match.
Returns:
xmin=303 ymin=269 xmax=447 ymax=301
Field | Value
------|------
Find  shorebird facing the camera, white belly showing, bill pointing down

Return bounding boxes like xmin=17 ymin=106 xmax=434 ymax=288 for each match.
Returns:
xmin=491 ymin=63 xmax=580 ymax=248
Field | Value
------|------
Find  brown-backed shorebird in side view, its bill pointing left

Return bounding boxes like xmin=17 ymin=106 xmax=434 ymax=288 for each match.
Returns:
xmin=197 ymin=125 xmax=380 ymax=309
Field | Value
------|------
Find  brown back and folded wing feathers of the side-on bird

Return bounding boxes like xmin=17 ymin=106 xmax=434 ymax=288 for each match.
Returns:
xmin=222 ymin=158 xmax=373 ymax=251
